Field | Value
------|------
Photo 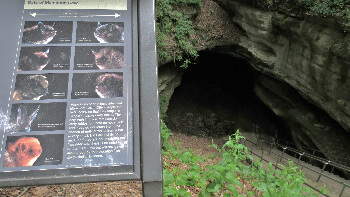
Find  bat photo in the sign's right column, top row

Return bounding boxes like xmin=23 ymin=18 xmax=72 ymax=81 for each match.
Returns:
xmin=77 ymin=21 xmax=124 ymax=43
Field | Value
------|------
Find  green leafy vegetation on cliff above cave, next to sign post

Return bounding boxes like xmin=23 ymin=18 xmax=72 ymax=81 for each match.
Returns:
xmin=156 ymin=0 xmax=201 ymax=68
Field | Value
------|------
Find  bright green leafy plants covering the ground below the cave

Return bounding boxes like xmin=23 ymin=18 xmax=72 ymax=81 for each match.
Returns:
xmin=162 ymin=123 xmax=326 ymax=197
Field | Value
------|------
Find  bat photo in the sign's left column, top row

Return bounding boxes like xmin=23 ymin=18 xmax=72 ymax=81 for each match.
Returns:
xmin=22 ymin=21 xmax=73 ymax=44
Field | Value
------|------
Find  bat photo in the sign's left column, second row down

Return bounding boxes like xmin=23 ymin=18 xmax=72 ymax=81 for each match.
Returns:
xmin=17 ymin=46 xmax=70 ymax=71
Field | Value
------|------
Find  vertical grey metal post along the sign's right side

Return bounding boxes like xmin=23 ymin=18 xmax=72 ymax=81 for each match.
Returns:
xmin=139 ymin=0 xmax=163 ymax=196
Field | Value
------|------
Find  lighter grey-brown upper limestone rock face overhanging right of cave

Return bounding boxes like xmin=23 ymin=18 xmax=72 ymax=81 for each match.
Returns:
xmin=218 ymin=0 xmax=350 ymax=132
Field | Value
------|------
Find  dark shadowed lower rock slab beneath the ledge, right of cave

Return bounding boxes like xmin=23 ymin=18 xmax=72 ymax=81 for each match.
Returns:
xmin=254 ymin=74 xmax=350 ymax=165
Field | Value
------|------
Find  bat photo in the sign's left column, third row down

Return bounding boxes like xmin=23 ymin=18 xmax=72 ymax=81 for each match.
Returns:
xmin=13 ymin=73 xmax=68 ymax=100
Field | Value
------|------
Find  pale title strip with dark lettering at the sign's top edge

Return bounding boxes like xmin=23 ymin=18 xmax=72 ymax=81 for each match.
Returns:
xmin=24 ymin=0 xmax=127 ymax=10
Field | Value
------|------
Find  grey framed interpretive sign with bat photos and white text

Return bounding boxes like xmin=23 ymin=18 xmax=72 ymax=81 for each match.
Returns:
xmin=0 ymin=0 xmax=161 ymax=195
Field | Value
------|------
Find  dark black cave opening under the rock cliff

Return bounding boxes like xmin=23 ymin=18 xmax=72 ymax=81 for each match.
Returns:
xmin=165 ymin=51 xmax=290 ymax=137
